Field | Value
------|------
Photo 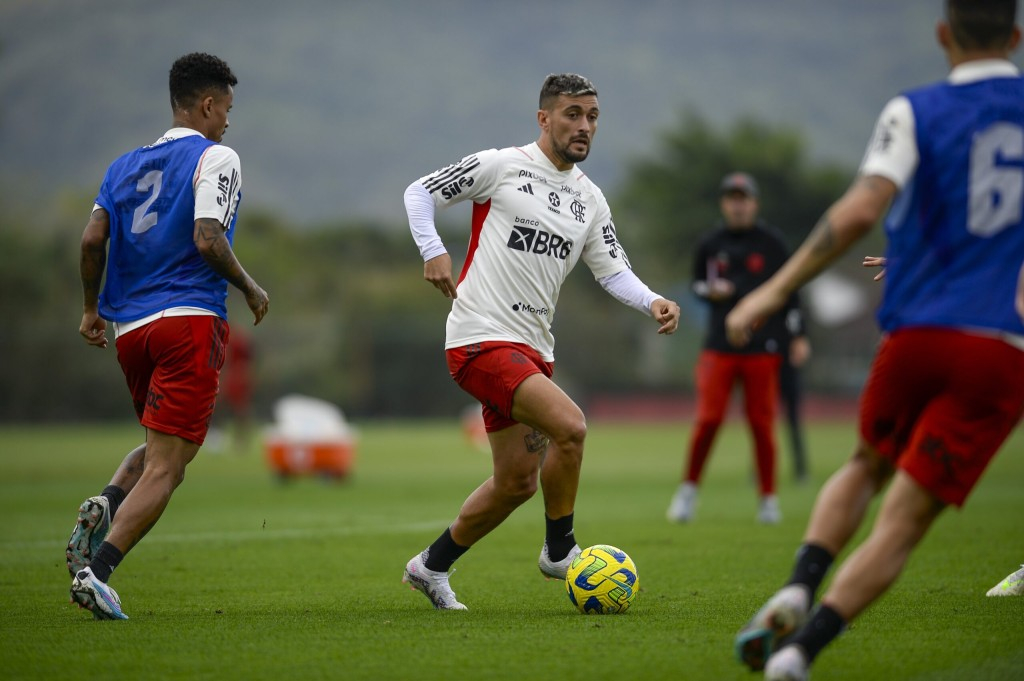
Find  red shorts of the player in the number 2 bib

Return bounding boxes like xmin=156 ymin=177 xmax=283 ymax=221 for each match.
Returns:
xmin=117 ymin=315 xmax=228 ymax=444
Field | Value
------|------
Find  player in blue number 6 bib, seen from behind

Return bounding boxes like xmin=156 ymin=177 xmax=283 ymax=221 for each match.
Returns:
xmin=726 ymin=0 xmax=1024 ymax=680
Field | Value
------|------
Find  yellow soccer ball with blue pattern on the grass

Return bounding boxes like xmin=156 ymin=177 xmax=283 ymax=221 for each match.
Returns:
xmin=565 ymin=544 xmax=640 ymax=614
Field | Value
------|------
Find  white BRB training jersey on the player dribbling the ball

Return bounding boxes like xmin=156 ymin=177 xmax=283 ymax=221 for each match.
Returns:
xmin=420 ymin=142 xmax=630 ymax=361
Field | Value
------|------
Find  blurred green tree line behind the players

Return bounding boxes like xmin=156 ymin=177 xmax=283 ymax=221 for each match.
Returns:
xmin=0 ymin=115 xmax=882 ymax=421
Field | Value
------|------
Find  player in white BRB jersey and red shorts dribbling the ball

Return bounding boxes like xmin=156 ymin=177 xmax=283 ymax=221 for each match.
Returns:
xmin=402 ymin=74 xmax=679 ymax=609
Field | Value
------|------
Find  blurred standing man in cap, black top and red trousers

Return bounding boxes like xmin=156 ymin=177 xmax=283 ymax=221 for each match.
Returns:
xmin=666 ymin=172 xmax=807 ymax=524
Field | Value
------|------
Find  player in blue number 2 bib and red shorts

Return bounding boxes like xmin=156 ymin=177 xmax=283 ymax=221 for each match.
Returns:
xmin=67 ymin=52 xmax=269 ymax=620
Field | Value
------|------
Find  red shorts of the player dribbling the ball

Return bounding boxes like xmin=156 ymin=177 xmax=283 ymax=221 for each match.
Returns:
xmin=444 ymin=341 xmax=555 ymax=433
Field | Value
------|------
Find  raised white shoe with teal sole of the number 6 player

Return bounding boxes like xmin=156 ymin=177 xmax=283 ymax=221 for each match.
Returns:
xmin=735 ymin=584 xmax=811 ymax=678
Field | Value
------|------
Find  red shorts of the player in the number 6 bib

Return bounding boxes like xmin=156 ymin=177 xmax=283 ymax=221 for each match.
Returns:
xmin=860 ymin=329 xmax=1024 ymax=506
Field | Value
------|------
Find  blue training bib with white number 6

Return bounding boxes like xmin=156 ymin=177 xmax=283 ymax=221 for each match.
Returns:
xmin=878 ymin=72 xmax=1024 ymax=335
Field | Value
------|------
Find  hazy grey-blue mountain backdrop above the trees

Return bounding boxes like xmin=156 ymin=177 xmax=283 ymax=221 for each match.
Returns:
xmin=0 ymin=0 xmax=966 ymax=225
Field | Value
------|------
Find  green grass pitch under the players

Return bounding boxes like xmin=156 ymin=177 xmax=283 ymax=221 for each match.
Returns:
xmin=0 ymin=423 xmax=1024 ymax=681
